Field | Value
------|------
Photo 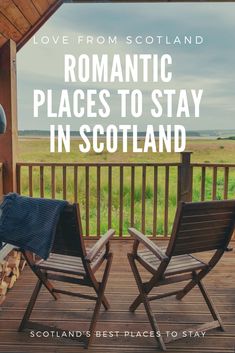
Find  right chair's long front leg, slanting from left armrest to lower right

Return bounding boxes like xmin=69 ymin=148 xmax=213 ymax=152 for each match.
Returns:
xmin=127 ymin=254 xmax=166 ymax=351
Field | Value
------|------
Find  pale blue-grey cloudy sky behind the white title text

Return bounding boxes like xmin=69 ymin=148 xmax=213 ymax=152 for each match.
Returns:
xmin=17 ymin=3 xmax=235 ymax=130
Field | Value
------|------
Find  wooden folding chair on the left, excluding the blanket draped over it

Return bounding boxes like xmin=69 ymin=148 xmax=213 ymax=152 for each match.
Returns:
xmin=19 ymin=204 xmax=115 ymax=347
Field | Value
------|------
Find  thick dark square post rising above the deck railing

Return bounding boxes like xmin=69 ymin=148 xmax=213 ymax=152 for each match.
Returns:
xmin=178 ymin=152 xmax=193 ymax=203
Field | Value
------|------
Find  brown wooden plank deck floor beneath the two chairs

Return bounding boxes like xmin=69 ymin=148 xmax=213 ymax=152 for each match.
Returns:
xmin=0 ymin=240 xmax=235 ymax=353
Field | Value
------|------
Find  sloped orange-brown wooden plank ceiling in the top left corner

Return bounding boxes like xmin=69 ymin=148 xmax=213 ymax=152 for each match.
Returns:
xmin=0 ymin=0 xmax=63 ymax=50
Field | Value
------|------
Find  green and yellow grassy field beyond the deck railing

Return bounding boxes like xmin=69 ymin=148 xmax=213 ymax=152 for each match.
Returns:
xmin=18 ymin=138 xmax=235 ymax=234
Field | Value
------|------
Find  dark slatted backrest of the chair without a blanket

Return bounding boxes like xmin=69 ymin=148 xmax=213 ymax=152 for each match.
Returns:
xmin=166 ymin=200 xmax=235 ymax=257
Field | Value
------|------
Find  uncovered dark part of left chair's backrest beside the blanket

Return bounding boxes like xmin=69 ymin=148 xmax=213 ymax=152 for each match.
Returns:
xmin=51 ymin=204 xmax=86 ymax=257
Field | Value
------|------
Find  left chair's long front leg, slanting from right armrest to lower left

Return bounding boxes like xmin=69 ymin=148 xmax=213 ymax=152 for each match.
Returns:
xmin=86 ymin=253 xmax=113 ymax=348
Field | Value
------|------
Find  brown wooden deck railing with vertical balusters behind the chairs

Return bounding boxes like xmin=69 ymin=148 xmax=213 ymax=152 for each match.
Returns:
xmin=17 ymin=152 xmax=235 ymax=237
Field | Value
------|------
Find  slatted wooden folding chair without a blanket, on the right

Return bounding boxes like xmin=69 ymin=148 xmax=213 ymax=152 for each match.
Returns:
xmin=128 ymin=200 xmax=235 ymax=350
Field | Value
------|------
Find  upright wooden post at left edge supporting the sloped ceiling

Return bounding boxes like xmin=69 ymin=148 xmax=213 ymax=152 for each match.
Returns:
xmin=0 ymin=40 xmax=18 ymax=194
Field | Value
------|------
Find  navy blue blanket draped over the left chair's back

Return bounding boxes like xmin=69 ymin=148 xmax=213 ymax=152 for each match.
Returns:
xmin=0 ymin=193 xmax=68 ymax=259
